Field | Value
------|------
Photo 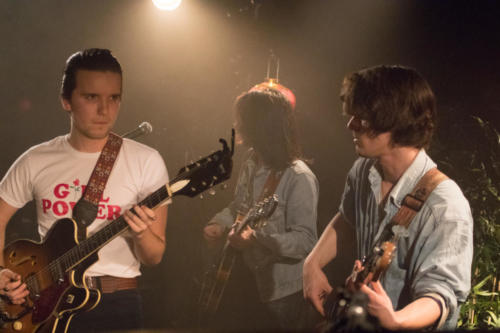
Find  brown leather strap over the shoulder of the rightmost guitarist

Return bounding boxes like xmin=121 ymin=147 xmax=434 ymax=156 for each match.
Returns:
xmin=391 ymin=168 xmax=448 ymax=228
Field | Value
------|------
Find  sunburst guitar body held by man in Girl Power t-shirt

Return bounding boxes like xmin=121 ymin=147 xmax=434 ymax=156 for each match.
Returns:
xmin=2 ymin=219 xmax=100 ymax=333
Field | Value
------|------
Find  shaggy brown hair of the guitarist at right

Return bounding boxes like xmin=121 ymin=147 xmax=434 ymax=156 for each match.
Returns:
xmin=340 ymin=65 xmax=436 ymax=148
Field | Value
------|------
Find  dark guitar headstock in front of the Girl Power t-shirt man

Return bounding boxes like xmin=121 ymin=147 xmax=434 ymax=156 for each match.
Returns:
xmin=170 ymin=130 xmax=234 ymax=197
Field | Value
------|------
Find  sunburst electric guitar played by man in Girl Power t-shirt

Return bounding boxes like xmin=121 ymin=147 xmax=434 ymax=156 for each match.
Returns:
xmin=0 ymin=136 xmax=234 ymax=333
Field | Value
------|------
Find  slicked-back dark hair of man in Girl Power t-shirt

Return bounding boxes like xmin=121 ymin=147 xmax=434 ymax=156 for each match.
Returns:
xmin=61 ymin=48 xmax=122 ymax=100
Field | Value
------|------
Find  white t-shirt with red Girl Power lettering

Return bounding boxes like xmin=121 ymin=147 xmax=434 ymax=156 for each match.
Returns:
xmin=0 ymin=135 xmax=168 ymax=277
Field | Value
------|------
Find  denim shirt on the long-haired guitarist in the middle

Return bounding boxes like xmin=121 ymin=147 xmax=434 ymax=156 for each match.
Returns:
xmin=209 ymin=154 xmax=319 ymax=302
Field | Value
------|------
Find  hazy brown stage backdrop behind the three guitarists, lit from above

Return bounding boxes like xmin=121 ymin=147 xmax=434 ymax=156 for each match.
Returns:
xmin=0 ymin=0 xmax=500 ymax=328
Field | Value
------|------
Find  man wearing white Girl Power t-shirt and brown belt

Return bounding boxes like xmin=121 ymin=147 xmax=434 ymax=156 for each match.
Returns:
xmin=0 ymin=49 xmax=168 ymax=332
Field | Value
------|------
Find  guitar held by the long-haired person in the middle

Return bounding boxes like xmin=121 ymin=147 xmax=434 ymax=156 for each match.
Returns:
xmin=198 ymin=195 xmax=278 ymax=323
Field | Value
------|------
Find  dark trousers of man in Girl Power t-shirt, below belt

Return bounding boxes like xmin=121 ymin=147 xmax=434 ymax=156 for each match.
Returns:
xmin=68 ymin=289 xmax=143 ymax=333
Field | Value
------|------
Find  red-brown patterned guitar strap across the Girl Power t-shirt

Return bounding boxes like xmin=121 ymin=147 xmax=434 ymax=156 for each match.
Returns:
xmin=73 ymin=133 xmax=123 ymax=241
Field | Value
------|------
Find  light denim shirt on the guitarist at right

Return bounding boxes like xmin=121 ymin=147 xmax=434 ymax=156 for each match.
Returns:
xmin=340 ymin=150 xmax=473 ymax=329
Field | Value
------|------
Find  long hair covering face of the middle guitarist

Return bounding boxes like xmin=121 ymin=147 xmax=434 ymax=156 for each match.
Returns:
xmin=235 ymin=89 xmax=301 ymax=171
